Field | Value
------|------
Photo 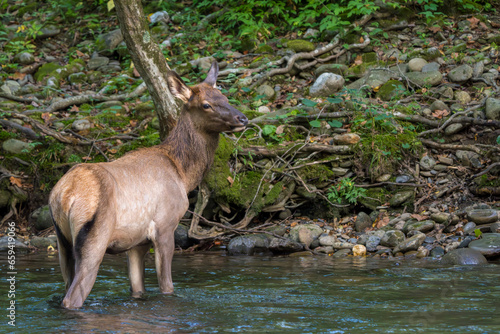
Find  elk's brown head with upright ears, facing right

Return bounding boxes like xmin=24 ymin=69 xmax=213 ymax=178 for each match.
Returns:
xmin=167 ymin=61 xmax=248 ymax=133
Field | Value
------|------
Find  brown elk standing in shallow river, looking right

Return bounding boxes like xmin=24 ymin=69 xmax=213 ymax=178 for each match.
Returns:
xmin=49 ymin=62 xmax=248 ymax=309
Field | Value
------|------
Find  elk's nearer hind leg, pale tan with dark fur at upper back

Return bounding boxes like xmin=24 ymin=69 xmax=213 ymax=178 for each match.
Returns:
xmin=62 ymin=218 xmax=113 ymax=309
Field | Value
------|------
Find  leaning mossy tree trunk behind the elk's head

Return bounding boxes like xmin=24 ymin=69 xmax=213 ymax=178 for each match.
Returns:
xmin=114 ymin=0 xmax=180 ymax=140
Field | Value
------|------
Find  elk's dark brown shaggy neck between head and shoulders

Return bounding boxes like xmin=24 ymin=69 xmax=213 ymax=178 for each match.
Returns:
xmin=161 ymin=113 xmax=219 ymax=192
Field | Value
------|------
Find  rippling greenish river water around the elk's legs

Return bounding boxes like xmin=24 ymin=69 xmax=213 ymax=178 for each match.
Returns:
xmin=0 ymin=253 xmax=500 ymax=333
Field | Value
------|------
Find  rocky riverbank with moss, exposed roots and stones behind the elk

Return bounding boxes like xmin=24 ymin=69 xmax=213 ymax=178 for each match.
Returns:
xmin=0 ymin=1 xmax=500 ymax=263
